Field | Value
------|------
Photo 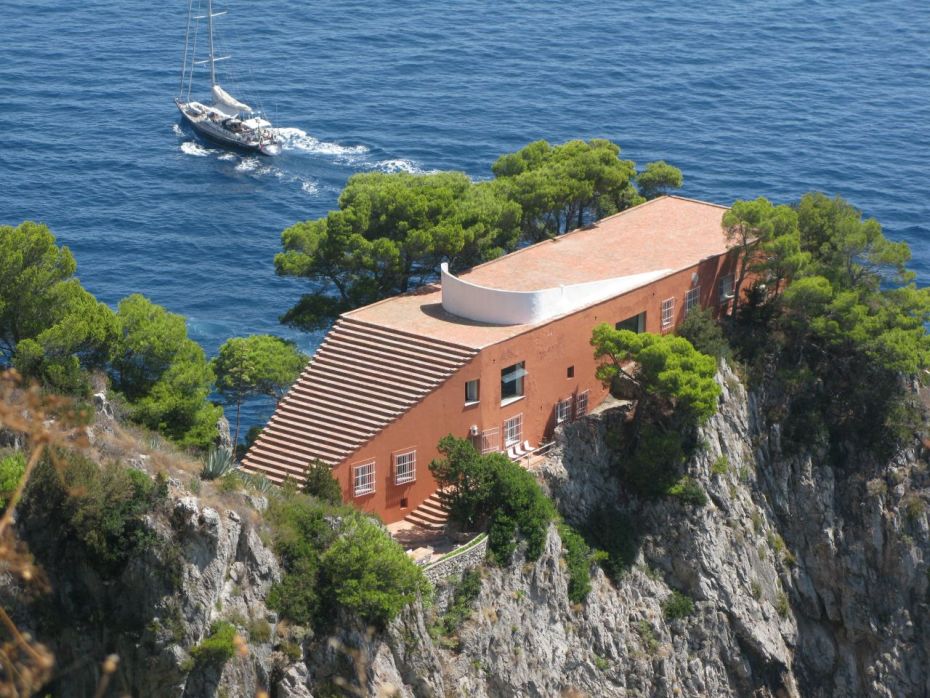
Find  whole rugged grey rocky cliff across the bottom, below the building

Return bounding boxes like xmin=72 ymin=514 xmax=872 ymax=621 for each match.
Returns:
xmin=9 ymin=368 xmax=930 ymax=698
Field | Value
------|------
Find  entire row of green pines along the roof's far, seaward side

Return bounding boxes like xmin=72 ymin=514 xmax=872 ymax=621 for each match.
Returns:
xmin=275 ymin=140 xmax=681 ymax=329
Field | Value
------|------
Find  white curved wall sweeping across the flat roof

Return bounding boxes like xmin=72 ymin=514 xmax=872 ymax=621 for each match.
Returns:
xmin=442 ymin=264 xmax=670 ymax=325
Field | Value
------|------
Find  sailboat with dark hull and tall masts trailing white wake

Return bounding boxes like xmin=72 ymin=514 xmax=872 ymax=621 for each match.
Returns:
xmin=174 ymin=0 xmax=282 ymax=155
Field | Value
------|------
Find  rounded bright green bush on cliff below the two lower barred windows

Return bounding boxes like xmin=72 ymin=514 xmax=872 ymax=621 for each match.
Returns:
xmin=320 ymin=514 xmax=430 ymax=627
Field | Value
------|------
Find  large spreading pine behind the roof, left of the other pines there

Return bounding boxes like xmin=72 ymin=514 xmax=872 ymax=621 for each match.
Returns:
xmin=275 ymin=172 xmax=520 ymax=328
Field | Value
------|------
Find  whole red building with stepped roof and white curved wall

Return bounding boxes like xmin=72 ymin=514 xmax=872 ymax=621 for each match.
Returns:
xmin=243 ymin=197 xmax=733 ymax=523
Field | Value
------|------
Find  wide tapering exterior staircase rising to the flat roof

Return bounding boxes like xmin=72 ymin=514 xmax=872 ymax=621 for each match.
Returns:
xmin=242 ymin=317 xmax=478 ymax=482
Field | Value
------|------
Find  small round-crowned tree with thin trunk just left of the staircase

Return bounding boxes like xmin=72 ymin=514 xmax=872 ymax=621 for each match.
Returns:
xmin=211 ymin=334 xmax=307 ymax=444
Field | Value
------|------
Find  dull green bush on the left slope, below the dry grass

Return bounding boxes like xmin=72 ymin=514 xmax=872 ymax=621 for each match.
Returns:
xmin=24 ymin=452 xmax=166 ymax=576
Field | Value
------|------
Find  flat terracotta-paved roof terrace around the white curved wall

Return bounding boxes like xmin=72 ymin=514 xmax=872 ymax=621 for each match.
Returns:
xmin=345 ymin=196 xmax=727 ymax=349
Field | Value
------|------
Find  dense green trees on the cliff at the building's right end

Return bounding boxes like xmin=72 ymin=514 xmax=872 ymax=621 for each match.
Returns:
xmin=725 ymin=193 xmax=930 ymax=458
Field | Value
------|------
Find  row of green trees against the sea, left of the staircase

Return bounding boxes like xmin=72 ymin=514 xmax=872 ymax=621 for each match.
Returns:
xmin=0 ymin=222 xmax=306 ymax=448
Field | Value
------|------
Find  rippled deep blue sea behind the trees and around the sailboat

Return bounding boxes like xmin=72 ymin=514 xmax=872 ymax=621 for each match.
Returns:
xmin=0 ymin=0 xmax=930 ymax=424
